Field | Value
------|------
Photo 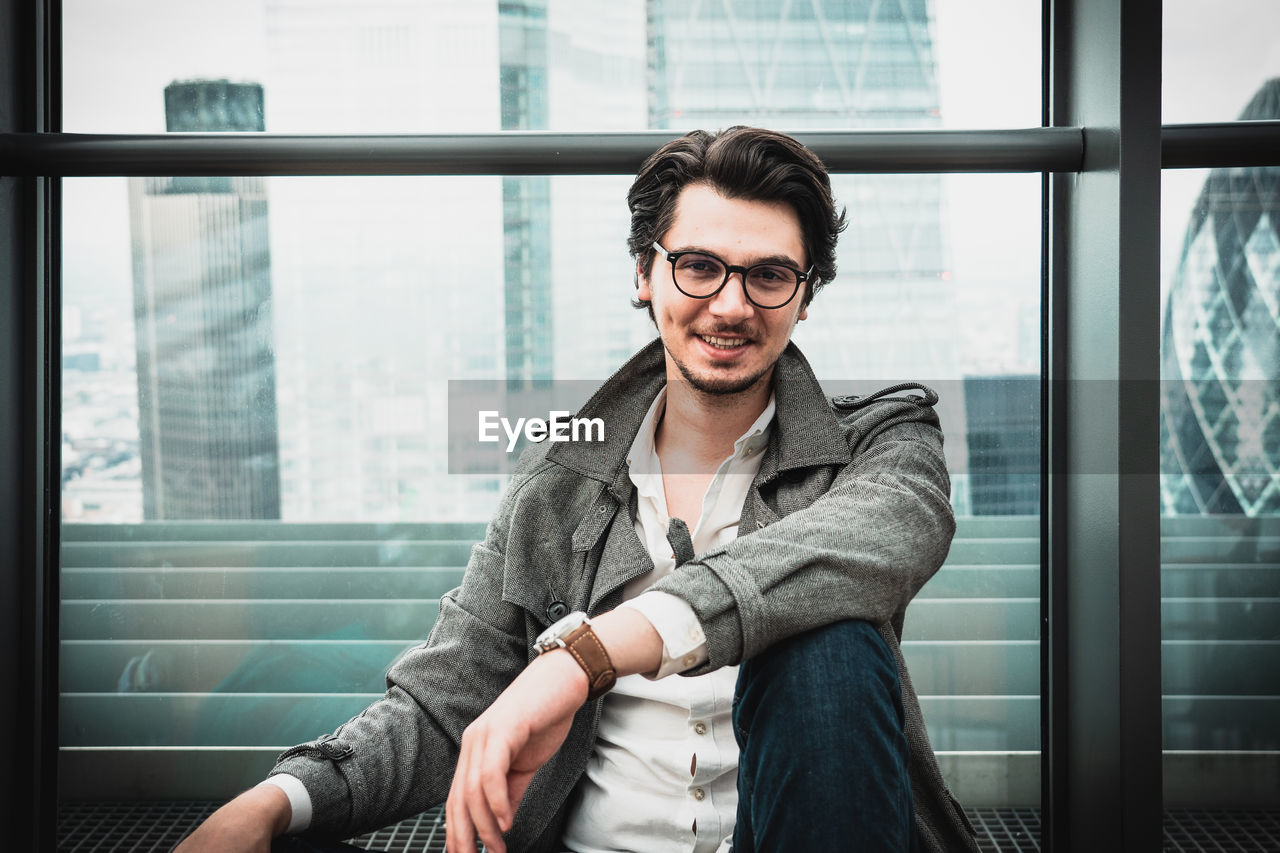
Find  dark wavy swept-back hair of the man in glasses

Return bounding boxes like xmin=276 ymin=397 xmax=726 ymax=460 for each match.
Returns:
xmin=627 ymin=126 xmax=846 ymax=318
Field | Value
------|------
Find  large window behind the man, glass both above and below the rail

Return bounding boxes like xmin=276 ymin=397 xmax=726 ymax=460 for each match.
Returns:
xmin=55 ymin=3 xmax=1041 ymax=804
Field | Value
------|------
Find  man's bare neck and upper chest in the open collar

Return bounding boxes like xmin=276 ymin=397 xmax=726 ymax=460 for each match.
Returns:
xmin=655 ymin=370 xmax=773 ymax=474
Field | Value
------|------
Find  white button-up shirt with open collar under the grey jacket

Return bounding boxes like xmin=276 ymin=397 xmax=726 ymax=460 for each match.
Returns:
xmin=564 ymin=389 xmax=774 ymax=853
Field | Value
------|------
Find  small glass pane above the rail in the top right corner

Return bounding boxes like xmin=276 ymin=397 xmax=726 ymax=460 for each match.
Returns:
xmin=1162 ymin=0 xmax=1280 ymax=124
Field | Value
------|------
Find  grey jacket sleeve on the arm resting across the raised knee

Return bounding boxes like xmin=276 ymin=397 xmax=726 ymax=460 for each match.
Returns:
xmin=653 ymin=402 xmax=955 ymax=675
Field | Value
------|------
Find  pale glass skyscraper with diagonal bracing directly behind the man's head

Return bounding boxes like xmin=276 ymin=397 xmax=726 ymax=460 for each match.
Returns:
xmin=648 ymin=0 xmax=956 ymax=380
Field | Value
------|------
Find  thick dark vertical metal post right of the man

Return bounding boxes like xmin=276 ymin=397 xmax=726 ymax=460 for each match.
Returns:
xmin=1041 ymin=0 xmax=1162 ymax=850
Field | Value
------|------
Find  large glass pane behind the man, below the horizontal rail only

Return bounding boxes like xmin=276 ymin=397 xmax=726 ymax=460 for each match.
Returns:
xmin=61 ymin=175 xmax=1041 ymax=806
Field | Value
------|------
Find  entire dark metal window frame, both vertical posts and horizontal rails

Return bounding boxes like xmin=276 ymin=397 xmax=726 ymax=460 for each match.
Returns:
xmin=0 ymin=0 xmax=1280 ymax=850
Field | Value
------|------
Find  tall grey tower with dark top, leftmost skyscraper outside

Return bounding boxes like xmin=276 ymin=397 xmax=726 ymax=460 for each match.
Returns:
xmin=129 ymin=79 xmax=280 ymax=520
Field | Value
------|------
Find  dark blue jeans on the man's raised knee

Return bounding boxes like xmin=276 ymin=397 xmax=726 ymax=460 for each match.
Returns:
xmin=733 ymin=621 xmax=915 ymax=853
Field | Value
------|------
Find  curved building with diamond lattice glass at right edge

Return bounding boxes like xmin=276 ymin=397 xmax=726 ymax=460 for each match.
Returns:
xmin=1160 ymin=78 xmax=1280 ymax=516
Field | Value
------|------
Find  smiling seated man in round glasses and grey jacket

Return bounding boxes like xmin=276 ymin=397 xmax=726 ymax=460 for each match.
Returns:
xmin=180 ymin=128 xmax=977 ymax=853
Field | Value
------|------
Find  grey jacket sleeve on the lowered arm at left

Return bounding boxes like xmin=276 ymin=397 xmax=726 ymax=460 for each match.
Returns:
xmin=271 ymin=455 xmax=547 ymax=838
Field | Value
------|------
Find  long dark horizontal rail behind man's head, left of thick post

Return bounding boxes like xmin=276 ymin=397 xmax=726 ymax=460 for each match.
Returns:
xmin=0 ymin=128 xmax=1084 ymax=177
